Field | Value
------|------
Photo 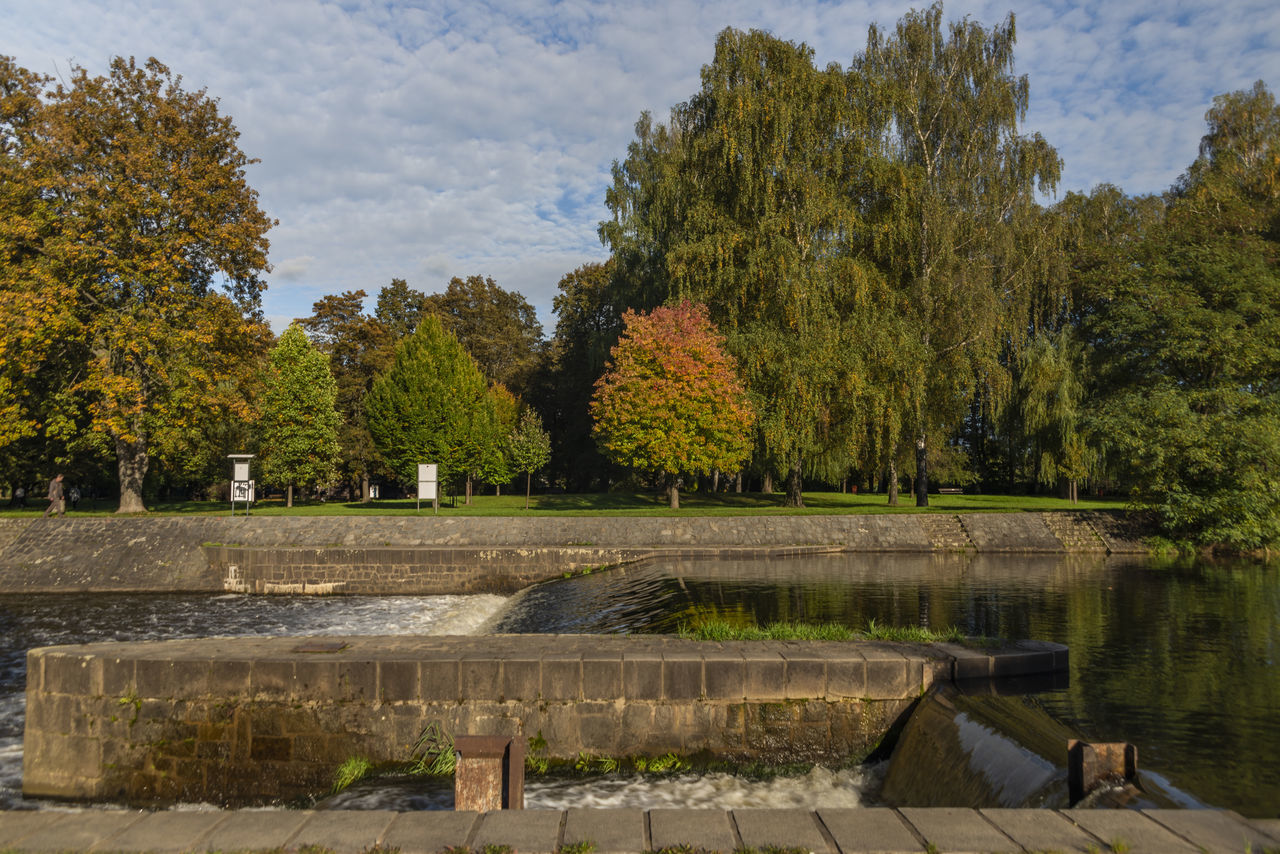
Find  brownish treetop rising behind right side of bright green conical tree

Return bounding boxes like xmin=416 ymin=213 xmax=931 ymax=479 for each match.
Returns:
xmin=426 ymin=275 xmax=543 ymax=396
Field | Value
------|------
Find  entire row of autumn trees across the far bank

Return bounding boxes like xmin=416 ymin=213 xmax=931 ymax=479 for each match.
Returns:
xmin=0 ymin=5 xmax=1280 ymax=548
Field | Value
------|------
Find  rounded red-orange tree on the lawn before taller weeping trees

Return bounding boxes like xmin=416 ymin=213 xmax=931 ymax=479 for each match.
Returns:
xmin=591 ymin=302 xmax=755 ymax=510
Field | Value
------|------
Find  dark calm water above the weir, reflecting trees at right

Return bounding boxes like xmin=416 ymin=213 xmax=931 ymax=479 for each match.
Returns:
xmin=494 ymin=554 xmax=1280 ymax=817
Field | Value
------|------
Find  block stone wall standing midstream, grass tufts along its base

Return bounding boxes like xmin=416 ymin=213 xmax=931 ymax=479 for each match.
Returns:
xmin=23 ymin=635 xmax=1068 ymax=805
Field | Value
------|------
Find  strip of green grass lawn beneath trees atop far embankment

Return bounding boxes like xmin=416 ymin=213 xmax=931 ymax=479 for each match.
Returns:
xmin=0 ymin=492 xmax=1125 ymax=517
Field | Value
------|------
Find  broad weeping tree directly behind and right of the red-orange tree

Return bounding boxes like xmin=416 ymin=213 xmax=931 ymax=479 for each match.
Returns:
xmin=602 ymin=29 xmax=879 ymax=506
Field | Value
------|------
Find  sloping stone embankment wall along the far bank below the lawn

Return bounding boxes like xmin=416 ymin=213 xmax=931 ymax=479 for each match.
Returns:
xmin=0 ymin=512 xmax=1146 ymax=594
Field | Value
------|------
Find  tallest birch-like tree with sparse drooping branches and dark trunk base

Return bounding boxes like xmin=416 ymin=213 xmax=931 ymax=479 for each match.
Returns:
xmin=850 ymin=4 xmax=1061 ymax=506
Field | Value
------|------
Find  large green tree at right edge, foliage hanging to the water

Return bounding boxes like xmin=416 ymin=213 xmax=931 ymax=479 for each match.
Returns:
xmin=1082 ymin=83 xmax=1280 ymax=548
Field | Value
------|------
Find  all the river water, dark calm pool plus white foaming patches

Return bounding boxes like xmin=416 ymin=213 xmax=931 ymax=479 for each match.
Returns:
xmin=0 ymin=554 xmax=1280 ymax=817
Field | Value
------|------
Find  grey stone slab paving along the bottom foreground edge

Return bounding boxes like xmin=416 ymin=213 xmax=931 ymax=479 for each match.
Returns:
xmin=0 ymin=808 xmax=1280 ymax=854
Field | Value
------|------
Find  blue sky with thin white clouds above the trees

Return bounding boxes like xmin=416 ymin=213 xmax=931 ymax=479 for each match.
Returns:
xmin=0 ymin=0 xmax=1280 ymax=334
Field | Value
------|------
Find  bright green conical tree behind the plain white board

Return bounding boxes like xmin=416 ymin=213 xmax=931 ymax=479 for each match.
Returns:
xmin=365 ymin=315 xmax=495 ymax=496
